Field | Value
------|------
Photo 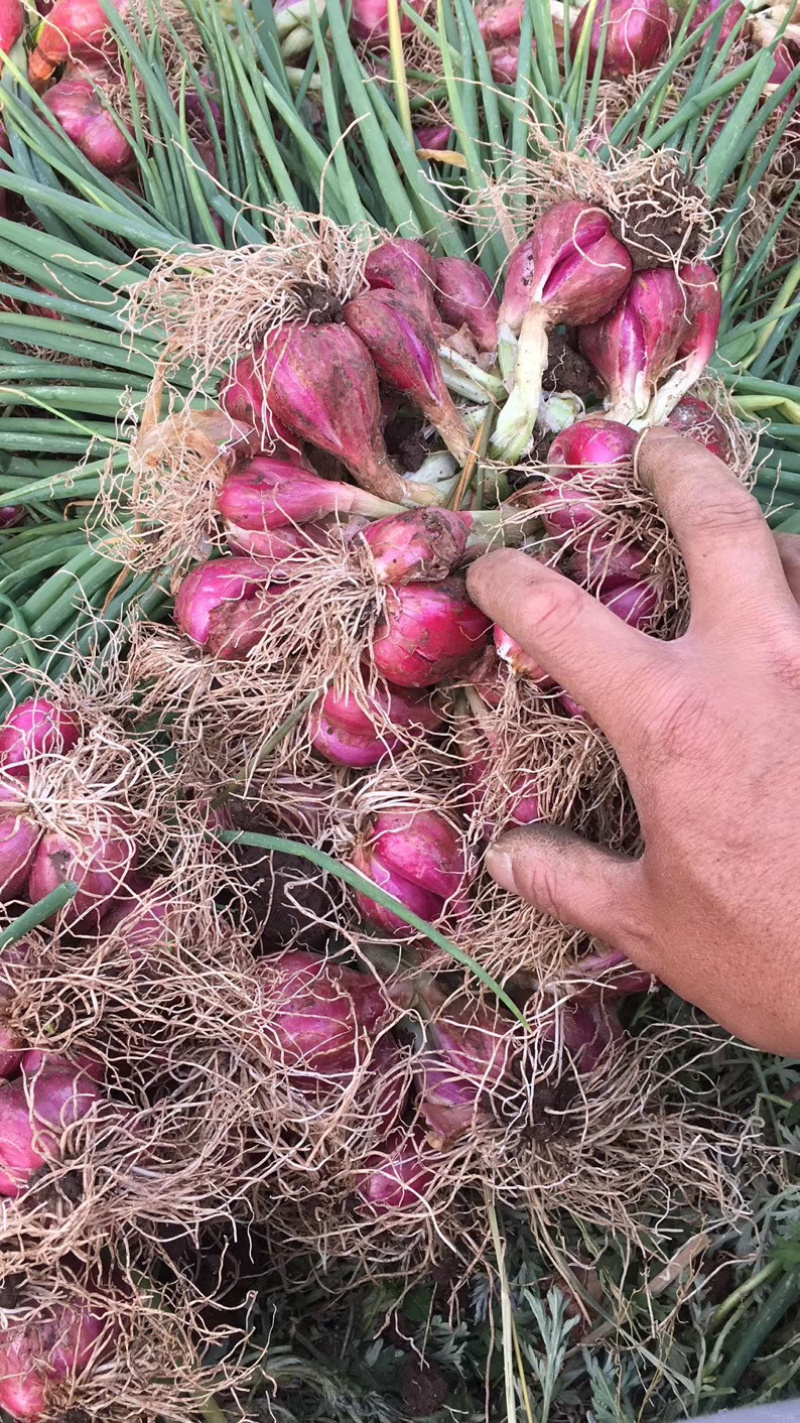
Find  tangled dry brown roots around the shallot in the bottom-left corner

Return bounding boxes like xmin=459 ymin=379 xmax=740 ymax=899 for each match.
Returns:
xmin=0 ymin=1252 xmax=254 ymax=1423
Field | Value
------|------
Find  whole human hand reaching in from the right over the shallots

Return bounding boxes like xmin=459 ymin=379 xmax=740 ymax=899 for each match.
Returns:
xmin=468 ymin=428 xmax=800 ymax=1056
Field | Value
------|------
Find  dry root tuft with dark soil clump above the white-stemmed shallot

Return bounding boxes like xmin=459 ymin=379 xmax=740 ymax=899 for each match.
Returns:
xmin=468 ymin=128 xmax=716 ymax=268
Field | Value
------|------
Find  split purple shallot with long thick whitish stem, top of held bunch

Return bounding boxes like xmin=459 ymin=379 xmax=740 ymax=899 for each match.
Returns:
xmin=491 ymin=202 xmax=632 ymax=462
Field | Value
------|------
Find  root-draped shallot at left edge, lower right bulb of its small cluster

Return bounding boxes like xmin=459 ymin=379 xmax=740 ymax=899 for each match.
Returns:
xmin=28 ymin=818 xmax=138 ymax=929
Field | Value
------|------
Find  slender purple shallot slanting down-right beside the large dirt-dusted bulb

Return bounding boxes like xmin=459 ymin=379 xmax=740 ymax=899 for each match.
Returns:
xmin=343 ymin=290 xmax=471 ymax=464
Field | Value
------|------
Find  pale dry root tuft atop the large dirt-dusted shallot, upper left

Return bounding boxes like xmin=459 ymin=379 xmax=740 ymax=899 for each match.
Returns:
xmin=127 ymin=208 xmax=379 ymax=388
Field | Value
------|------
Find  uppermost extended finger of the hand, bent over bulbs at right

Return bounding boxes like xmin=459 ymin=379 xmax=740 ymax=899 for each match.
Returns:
xmin=635 ymin=427 xmax=797 ymax=633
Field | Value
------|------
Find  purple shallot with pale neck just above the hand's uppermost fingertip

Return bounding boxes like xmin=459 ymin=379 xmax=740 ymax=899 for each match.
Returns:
xmin=579 ymin=268 xmax=689 ymax=423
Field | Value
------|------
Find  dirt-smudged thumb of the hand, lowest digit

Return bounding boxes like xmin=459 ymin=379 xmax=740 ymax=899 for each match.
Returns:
xmin=485 ymin=822 xmax=653 ymax=969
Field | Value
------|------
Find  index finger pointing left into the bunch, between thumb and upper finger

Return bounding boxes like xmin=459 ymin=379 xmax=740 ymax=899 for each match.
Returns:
xmin=467 ymin=548 xmax=663 ymax=746
